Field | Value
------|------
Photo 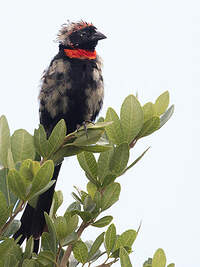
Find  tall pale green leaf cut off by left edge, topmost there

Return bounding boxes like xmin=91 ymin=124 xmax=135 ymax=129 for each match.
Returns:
xmin=0 ymin=115 xmax=10 ymax=168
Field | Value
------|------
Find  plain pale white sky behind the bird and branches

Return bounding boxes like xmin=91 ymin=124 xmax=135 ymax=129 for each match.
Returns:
xmin=0 ymin=0 xmax=200 ymax=267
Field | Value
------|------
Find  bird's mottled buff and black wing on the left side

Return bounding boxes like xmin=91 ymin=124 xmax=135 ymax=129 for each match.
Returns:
xmin=39 ymin=59 xmax=71 ymax=132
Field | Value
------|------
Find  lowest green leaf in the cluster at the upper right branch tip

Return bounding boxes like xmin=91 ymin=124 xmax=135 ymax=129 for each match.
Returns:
xmin=137 ymin=116 xmax=160 ymax=139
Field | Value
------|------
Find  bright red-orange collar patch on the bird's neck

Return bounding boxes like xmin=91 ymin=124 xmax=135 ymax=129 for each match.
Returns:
xmin=64 ymin=49 xmax=97 ymax=59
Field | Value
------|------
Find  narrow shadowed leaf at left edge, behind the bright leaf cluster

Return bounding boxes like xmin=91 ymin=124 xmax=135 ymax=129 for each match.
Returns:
xmin=0 ymin=169 xmax=17 ymax=206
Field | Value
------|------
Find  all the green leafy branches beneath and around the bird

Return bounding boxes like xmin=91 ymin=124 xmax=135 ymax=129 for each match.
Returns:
xmin=0 ymin=92 xmax=174 ymax=267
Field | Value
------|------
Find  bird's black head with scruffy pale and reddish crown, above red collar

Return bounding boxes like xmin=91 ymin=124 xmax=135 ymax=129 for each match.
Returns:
xmin=58 ymin=21 xmax=106 ymax=51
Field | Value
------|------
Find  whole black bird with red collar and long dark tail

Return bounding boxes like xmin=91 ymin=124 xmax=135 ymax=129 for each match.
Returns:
xmin=13 ymin=20 xmax=106 ymax=253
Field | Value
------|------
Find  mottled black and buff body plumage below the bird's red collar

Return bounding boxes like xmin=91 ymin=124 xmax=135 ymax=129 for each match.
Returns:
xmin=39 ymin=51 xmax=104 ymax=134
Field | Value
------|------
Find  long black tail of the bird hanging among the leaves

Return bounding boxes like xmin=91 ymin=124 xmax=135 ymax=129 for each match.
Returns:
xmin=13 ymin=164 xmax=61 ymax=253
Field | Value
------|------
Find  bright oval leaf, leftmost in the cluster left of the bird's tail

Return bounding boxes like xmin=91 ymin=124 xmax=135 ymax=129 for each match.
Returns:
xmin=8 ymin=169 xmax=27 ymax=201
